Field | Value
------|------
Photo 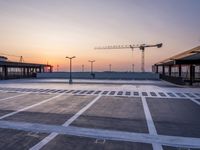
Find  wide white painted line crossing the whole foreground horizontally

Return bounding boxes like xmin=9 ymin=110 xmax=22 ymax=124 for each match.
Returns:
xmin=0 ymin=121 xmax=200 ymax=148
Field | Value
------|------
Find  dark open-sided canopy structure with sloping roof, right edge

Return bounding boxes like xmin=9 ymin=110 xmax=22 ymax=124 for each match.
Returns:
xmin=153 ymin=46 xmax=200 ymax=85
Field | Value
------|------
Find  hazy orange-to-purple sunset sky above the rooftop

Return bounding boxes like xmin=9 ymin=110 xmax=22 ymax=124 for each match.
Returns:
xmin=0 ymin=0 xmax=200 ymax=71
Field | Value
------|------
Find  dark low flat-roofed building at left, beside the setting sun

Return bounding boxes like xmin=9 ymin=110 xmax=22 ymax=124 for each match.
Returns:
xmin=0 ymin=56 xmax=53 ymax=80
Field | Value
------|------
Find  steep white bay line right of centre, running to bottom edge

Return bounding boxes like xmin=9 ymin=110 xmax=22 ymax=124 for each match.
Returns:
xmin=141 ymin=96 xmax=163 ymax=150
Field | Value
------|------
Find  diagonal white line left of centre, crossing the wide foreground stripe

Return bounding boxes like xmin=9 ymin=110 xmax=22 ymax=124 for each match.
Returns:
xmin=30 ymin=95 xmax=101 ymax=150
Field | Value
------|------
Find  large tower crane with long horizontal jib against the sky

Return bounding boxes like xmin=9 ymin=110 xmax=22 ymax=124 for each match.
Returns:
xmin=94 ymin=43 xmax=163 ymax=72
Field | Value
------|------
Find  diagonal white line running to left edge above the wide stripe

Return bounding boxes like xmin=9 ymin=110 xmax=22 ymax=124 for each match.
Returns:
xmin=0 ymin=93 xmax=64 ymax=119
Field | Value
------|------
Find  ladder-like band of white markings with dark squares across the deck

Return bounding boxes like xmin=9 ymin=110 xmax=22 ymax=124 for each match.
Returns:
xmin=0 ymin=87 xmax=200 ymax=99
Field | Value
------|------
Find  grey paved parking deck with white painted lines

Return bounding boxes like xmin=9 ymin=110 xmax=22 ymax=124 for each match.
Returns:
xmin=0 ymin=80 xmax=200 ymax=150
